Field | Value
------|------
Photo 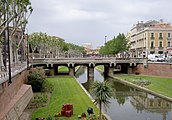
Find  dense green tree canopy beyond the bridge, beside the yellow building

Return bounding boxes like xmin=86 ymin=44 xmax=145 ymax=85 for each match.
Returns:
xmin=99 ymin=33 xmax=130 ymax=55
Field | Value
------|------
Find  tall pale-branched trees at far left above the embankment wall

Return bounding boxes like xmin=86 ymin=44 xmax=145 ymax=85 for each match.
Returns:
xmin=0 ymin=0 xmax=33 ymax=65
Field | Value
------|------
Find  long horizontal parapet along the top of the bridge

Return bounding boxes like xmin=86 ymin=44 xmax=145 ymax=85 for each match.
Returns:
xmin=30 ymin=57 xmax=147 ymax=65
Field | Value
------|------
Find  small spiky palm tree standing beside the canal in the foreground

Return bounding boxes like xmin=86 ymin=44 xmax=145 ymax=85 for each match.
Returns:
xmin=91 ymin=81 xmax=113 ymax=120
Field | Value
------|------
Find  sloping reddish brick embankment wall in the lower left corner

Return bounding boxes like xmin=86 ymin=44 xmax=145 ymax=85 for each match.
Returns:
xmin=0 ymin=69 xmax=33 ymax=120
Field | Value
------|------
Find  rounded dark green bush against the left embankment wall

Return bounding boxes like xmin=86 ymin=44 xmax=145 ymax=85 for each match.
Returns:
xmin=28 ymin=67 xmax=46 ymax=92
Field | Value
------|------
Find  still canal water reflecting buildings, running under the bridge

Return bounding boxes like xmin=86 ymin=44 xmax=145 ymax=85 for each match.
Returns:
xmin=76 ymin=67 xmax=172 ymax=120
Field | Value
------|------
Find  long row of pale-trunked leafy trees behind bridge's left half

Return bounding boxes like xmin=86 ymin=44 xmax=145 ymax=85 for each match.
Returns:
xmin=28 ymin=32 xmax=84 ymax=55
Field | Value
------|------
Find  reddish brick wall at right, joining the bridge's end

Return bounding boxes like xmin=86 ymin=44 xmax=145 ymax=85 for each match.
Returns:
xmin=133 ymin=63 xmax=172 ymax=78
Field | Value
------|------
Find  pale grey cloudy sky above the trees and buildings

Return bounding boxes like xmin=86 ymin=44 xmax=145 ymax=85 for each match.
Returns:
xmin=28 ymin=0 xmax=172 ymax=48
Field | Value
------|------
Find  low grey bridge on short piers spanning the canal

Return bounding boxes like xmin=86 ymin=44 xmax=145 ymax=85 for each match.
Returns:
xmin=29 ymin=55 xmax=147 ymax=78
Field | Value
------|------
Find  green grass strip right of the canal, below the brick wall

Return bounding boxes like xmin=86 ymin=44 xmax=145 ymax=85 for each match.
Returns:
xmin=117 ymin=75 xmax=172 ymax=97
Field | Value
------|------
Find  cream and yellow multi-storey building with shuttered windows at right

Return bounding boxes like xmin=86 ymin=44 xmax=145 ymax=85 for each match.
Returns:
xmin=127 ymin=20 xmax=172 ymax=57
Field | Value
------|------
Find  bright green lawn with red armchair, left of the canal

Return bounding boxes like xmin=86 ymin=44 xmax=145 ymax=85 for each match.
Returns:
xmin=32 ymin=76 xmax=98 ymax=120
